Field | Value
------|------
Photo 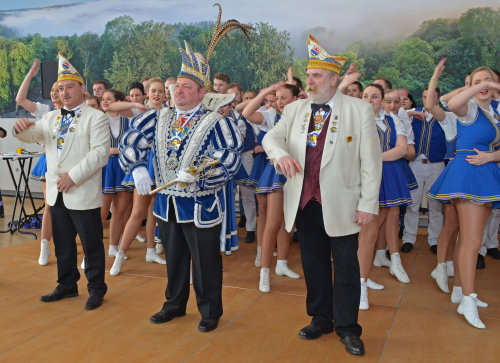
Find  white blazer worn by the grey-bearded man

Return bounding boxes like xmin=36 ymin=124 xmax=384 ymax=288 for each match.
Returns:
xmin=263 ymin=92 xmax=382 ymax=237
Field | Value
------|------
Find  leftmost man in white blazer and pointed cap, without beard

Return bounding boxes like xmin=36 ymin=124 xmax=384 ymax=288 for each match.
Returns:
xmin=15 ymin=54 xmax=110 ymax=310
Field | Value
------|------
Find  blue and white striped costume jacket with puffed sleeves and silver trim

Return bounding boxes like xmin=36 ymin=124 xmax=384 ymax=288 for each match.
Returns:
xmin=120 ymin=104 xmax=242 ymax=228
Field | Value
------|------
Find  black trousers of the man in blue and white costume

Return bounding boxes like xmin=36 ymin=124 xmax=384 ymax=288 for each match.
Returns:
xmin=158 ymin=204 xmax=222 ymax=319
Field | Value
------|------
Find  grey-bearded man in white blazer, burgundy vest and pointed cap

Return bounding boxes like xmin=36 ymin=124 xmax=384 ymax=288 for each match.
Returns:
xmin=263 ymin=35 xmax=382 ymax=355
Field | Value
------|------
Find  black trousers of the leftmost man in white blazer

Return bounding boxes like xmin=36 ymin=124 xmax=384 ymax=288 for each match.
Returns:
xmin=50 ymin=193 xmax=107 ymax=296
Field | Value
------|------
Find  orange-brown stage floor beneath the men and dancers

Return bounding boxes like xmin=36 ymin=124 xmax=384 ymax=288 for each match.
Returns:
xmin=0 ymin=197 xmax=500 ymax=362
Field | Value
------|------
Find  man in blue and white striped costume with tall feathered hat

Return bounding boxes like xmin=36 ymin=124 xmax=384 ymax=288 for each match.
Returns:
xmin=120 ymin=42 xmax=246 ymax=332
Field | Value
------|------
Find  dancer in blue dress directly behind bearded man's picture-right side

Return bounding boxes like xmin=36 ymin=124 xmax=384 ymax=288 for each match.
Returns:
xmin=358 ymin=84 xmax=411 ymax=310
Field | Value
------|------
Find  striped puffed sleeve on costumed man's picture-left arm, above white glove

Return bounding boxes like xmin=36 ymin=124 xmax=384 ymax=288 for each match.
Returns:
xmin=119 ymin=109 xmax=159 ymax=174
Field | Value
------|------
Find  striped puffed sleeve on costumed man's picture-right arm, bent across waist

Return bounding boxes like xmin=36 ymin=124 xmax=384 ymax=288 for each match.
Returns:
xmin=197 ymin=117 xmax=243 ymax=189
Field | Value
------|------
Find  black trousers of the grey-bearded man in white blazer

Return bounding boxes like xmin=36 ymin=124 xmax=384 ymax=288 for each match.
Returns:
xmin=296 ymin=201 xmax=362 ymax=337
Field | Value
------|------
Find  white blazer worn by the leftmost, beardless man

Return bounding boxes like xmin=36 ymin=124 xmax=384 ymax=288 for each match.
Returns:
xmin=16 ymin=103 xmax=110 ymax=210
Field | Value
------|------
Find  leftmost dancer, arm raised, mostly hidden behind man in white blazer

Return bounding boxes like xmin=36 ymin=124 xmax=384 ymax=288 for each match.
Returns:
xmin=16 ymin=59 xmax=63 ymax=266
